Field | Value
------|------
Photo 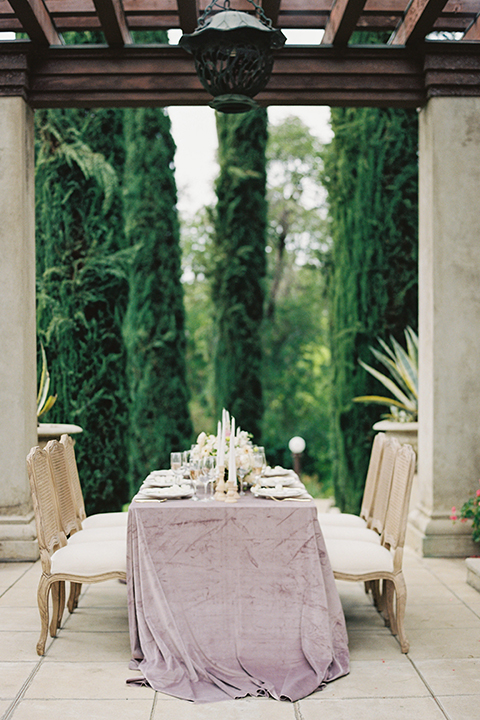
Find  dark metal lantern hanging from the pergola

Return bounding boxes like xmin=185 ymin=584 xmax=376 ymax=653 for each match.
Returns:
xmin=179 ymin=0 xmax=286 ymax=113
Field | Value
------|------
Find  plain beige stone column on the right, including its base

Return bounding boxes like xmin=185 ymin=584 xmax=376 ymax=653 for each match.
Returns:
xmin=408 ymin=97 xmax=480 ymax=556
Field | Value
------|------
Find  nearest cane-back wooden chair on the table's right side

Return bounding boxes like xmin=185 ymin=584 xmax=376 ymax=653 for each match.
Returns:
xmin=325 ymin=445 xmax=415 ymax=653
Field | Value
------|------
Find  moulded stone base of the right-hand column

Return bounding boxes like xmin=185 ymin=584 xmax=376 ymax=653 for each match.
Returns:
xmin=406 ymin=507 xmax=480 ymax=557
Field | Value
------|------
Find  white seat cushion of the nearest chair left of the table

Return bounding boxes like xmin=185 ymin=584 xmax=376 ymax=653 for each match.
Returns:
xmin=51 ymin=540 xmax=127 ymax=576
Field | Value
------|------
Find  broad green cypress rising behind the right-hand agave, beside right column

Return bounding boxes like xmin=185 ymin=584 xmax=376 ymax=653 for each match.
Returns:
xmin=324 ymin=108 xmax=418 ymax=512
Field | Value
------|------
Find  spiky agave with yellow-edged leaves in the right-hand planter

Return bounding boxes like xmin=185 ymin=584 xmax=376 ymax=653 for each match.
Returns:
xmin=353 ymin=327 xmax=418 ymax=422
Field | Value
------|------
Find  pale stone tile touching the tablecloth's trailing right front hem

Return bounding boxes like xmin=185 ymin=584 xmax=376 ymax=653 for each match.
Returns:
xmin=302 ymin=660 xmax=429 ymax=702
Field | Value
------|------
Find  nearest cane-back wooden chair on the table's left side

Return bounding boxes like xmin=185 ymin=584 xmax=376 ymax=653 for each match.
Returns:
xmin=27 ymin=447 xmax=126 ymax=655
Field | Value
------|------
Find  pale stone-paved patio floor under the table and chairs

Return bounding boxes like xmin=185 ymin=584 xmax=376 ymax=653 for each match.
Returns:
xmin=0 ymin=532 xmax=480 ymax=720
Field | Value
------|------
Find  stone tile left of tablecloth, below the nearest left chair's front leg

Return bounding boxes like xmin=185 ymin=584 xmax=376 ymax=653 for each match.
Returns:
xmin=45 ymin=629 xmax=131 ymax=667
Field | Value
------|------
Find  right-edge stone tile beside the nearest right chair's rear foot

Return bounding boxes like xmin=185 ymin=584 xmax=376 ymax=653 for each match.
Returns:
xmin=408 ymin=628 xmax=480 ymax=661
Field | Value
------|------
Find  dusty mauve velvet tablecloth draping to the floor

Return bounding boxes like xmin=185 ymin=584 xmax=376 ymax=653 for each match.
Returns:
xmin=127 ymin=494 xmax=349 ymax=702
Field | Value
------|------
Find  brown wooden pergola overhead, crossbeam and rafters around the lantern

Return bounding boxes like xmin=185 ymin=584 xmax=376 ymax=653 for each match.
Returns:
xmin=0 ymin=0 xmax=480 ymax=107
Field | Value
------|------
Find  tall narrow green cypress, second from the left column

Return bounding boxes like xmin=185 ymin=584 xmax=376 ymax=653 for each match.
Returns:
xmin=124 ymin=108 xmax=192 ymax=489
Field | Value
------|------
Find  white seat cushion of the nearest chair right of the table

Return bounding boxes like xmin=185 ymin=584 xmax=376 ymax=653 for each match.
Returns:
xmin=325 ymin=537 xmax=393 ymax=575
